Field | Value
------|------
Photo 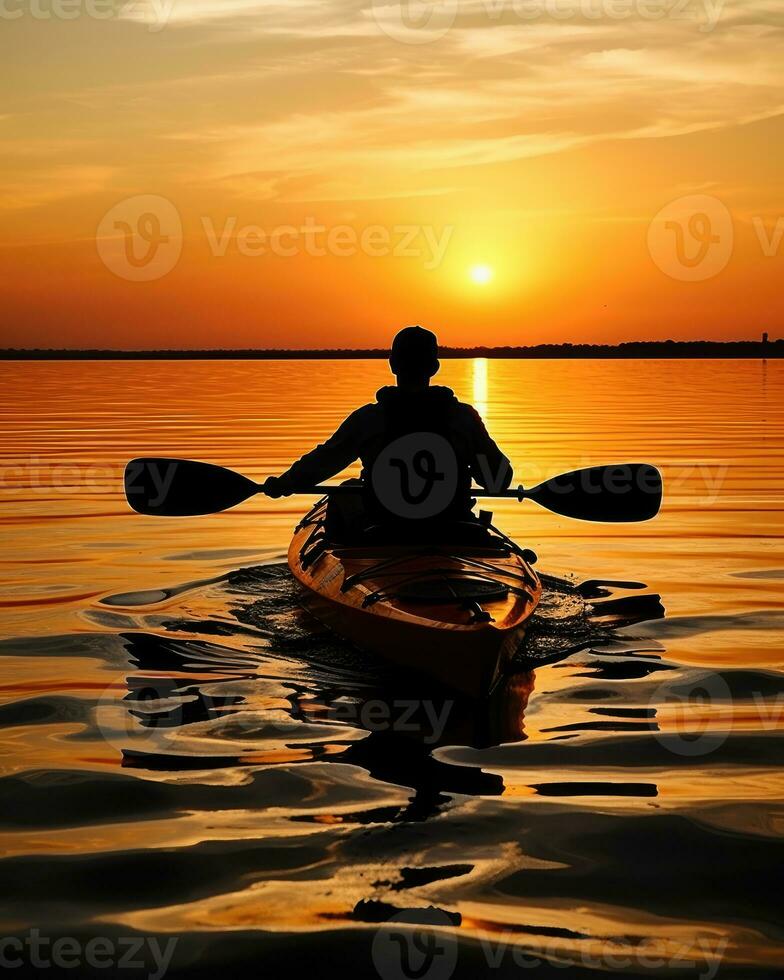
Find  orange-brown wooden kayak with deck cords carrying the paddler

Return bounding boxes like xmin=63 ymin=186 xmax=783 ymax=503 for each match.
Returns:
xmin=288 ymin=500 xmax=542 ymax=698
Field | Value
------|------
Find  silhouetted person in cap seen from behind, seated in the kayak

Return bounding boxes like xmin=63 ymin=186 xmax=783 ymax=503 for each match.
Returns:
xmin=263 ymin=327 xmax=512 ymax=523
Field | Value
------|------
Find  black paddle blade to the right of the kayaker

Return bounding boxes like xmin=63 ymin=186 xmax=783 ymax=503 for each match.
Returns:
xmin=525 ymin=463 xmax=662 ymax=524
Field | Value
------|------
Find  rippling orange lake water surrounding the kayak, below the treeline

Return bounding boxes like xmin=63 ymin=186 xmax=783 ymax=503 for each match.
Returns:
xmin=0 ymin=360 xmax=784 ymax=980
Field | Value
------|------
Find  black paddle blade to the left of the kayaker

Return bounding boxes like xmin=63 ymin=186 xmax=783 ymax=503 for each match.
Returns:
xmin=125 ymin=456 xmax=259 ymax=517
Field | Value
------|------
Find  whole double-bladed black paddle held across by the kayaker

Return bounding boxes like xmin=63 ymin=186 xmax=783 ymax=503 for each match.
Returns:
xmin=125 ymin=456 xmax=662 ymax=523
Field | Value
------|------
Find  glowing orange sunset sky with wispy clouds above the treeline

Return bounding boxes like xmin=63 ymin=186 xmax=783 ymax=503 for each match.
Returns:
xmin=0 ymin=0 xmax=784 ymax=348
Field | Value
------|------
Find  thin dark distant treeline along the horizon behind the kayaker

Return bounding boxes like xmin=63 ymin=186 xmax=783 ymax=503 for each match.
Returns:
xmin=0 ymin=340 xmax=784 ymax=361
